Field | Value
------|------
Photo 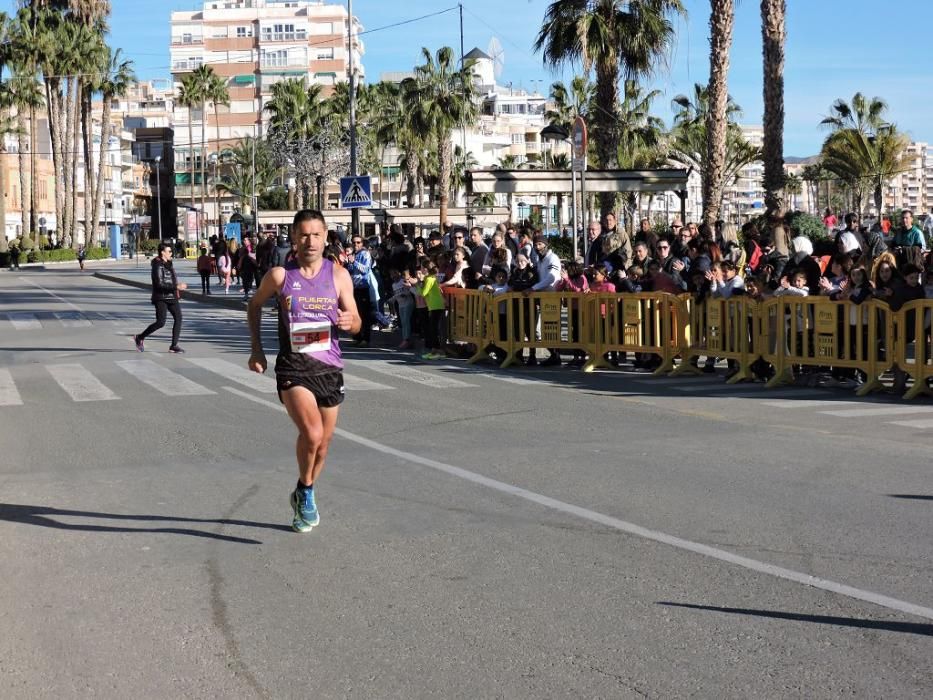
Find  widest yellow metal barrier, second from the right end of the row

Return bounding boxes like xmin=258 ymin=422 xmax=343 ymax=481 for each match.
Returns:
xmin=757 ymin=297 xmax=895 ymax=396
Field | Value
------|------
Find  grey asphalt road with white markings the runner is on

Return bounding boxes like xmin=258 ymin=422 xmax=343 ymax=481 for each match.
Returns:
xmin=0 ymin=267 xmax=933 ymax=698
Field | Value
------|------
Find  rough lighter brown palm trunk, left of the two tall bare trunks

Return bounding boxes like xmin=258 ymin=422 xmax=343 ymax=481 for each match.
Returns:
xmin=703 ymin=0 xmax=735 ymax=225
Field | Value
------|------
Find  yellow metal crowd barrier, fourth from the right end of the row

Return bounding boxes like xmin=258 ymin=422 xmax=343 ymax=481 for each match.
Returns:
xmin=581 ymin=292 xmax=687 ymax=375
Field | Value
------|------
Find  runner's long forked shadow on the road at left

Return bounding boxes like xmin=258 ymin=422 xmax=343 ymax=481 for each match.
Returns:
xmin=0 ymin=503 xmax=291 ymax=544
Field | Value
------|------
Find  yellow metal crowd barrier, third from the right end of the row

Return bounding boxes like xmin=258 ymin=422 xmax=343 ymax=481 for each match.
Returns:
xmin=672 ymin=296 xmax=762 ymax=384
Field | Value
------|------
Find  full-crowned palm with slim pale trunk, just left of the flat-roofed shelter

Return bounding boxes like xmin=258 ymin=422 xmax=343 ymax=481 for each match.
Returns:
xmin=402 ymin=46 xmax=477 ymax=228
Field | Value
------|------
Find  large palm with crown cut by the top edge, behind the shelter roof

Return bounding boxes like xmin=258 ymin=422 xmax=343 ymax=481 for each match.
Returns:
xmin=535 ymin=0 xmax=686 ymax=215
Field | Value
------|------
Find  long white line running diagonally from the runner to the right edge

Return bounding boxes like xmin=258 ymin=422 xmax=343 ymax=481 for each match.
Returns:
xmin=224 ymin=386 xmax=933 ymax=620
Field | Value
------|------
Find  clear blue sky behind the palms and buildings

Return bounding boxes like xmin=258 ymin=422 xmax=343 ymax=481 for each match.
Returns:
xmin=7 ymin=0 xmax=933 ymax=156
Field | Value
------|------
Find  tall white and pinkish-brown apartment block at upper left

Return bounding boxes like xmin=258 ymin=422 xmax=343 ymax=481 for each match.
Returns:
xmin=170 ymin=0 xmax=365 ymax=239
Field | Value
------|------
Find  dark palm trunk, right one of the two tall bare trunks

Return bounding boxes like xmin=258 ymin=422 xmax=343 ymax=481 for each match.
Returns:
xmin=761 ymin=0 xmax=787 ymax=216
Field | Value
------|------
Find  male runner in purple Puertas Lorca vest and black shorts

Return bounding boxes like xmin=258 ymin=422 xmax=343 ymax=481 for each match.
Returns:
xmin=247 ymin=209 xmax=361 ymax=532
